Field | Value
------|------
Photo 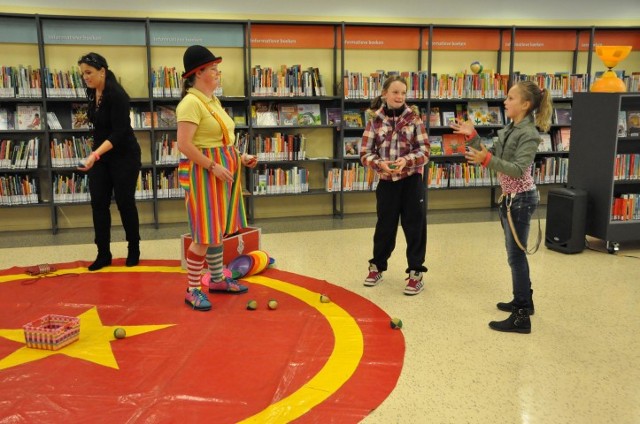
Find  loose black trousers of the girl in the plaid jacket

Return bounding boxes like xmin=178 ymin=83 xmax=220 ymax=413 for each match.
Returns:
xmin=369 ymin=174 xmax=427 ymax=272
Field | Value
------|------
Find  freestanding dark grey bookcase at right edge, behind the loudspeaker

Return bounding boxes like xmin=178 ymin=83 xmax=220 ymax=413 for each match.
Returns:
xmin=569 ymin=93 xmax=640 ymax=253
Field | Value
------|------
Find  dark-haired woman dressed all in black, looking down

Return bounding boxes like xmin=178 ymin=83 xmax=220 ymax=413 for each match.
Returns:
xmin=78 ymin=53 xmax=141 ymax=271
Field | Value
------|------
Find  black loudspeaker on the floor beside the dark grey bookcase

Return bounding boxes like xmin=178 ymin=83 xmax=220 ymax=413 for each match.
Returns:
xmin=544 ymin=188 xmax=587 ymax=253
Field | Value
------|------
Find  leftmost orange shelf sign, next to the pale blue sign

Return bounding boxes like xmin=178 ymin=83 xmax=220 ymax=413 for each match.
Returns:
xmin=251 ymin=24 xmax=334 ymax=49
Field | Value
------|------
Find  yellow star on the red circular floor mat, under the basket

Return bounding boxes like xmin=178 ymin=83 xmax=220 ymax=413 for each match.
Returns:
xmin=0 ymin=306 xmax=174 ymax=370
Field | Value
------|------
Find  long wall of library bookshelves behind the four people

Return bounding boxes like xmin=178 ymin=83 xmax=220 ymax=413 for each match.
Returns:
xmin=0 ymin=14 xmax=640 ymax=233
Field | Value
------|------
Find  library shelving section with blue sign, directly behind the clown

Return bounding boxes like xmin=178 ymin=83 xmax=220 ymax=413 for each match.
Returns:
xmin=147 ymin=20 xmax=248 ymax=227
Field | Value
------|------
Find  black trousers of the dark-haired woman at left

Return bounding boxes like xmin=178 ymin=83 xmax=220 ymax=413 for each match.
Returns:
xmin=89 ymin=157 xmax=140 ymax=253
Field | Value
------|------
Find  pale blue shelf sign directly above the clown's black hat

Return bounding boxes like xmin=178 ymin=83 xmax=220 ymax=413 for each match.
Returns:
xmin=149 ymin=22 xmax=244 ymax=47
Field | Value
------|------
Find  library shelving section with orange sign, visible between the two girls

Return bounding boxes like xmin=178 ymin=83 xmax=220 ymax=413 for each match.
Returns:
xmin=422 ymin=25 xmax=509 ymax=199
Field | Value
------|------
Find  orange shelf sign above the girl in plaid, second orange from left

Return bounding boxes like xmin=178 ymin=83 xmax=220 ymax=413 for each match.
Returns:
xmin=338 ymin=26 xmax=420 ymax=50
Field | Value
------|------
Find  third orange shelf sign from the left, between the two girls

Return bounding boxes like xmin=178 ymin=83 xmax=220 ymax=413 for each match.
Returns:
xmin=423 ymin=28 xmax=500 ymax=51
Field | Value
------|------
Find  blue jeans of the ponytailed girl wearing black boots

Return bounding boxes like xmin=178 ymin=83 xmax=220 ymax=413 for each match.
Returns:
xmin=499 ymin=189 xmax=540 ymax=308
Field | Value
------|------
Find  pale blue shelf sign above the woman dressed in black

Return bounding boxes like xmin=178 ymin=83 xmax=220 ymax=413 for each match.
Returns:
xmin=42 ymin=20 xmax=147 ymax=46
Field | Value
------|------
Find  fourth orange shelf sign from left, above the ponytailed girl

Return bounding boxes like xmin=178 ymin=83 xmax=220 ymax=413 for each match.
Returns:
xmin=502 ymin=29 xmax=576 ymax=51
